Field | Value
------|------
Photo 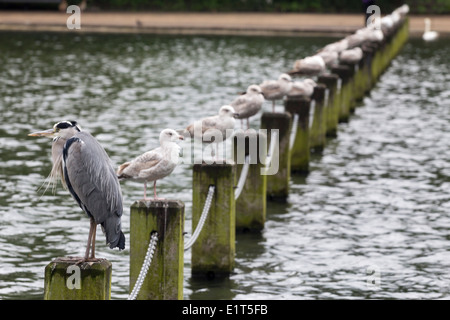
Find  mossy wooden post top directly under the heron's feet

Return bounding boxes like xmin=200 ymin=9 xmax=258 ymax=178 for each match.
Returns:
xmin=44 ymin=257 xmax=112 ymax=300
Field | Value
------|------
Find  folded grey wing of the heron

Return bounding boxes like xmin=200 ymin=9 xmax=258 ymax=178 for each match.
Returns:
xmin=63 ymin=132 xmax=125 ymax=248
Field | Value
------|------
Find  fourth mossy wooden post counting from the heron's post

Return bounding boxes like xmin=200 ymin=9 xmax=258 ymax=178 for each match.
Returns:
xmin=232 ymin=129 xmax=267 ymax=232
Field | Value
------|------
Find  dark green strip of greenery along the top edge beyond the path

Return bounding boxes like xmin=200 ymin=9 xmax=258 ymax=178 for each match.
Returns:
xmin=86 ymin=0 xmax=450 ymax=14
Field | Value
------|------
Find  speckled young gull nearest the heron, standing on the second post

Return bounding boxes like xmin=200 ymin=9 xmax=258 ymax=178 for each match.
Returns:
xmin=117 ymin=129 xmax=184 ymax=200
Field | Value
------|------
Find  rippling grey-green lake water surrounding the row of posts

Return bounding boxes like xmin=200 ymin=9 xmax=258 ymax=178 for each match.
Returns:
xmin=0 ymin=33 xmax=450 ymax=299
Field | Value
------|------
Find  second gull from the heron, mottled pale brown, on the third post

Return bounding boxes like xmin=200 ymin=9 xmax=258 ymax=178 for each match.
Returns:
xmin=179 ymin=105 xmax=239 ymax=159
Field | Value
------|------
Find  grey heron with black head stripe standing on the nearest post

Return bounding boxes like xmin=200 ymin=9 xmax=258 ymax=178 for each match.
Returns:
xmin=29 ymin=121 xmax=125 ymax=261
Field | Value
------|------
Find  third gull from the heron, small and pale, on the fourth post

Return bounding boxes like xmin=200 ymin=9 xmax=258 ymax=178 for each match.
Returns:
xmin=230 ymin=84 xmax=264 ymax=129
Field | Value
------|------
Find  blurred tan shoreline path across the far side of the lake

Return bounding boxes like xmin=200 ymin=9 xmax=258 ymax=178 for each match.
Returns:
xmin=0 ymin=10 xmax=450 ymax=37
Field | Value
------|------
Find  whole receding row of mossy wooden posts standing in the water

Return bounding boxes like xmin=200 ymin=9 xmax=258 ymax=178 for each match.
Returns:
xmin=44 ymin=12 xmax=408 ymax=300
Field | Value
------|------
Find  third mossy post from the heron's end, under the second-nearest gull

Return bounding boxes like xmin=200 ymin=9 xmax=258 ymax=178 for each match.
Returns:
xmin=191 ymin=163 xmax=236 ymax=278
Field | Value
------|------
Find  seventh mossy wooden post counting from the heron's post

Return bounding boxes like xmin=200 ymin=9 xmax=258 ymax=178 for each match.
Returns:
xmin=309 ymin=84 xmax=327 ymax=152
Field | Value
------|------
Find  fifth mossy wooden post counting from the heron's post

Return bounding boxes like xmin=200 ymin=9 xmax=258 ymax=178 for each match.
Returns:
xmin=261 ymin=112 xmax=292 ymax=201
